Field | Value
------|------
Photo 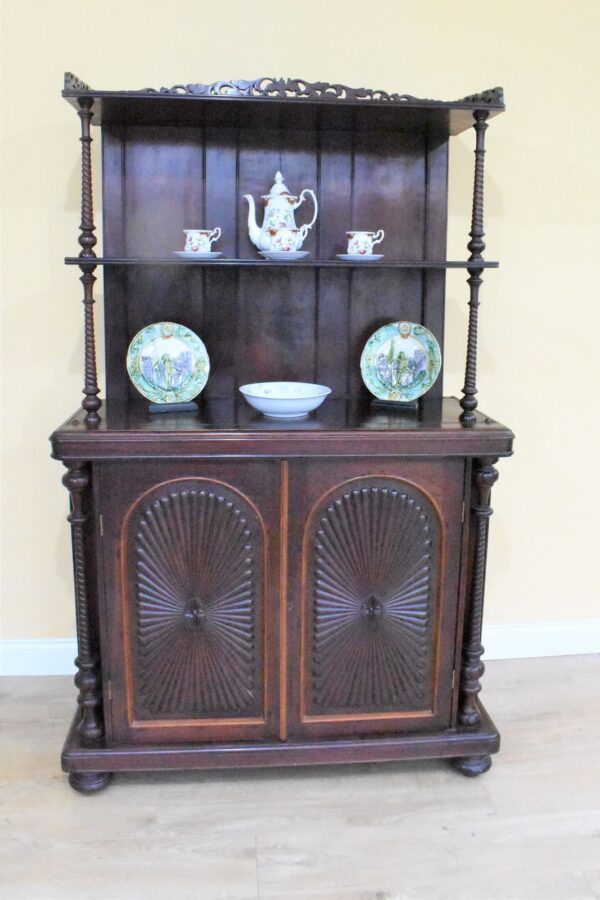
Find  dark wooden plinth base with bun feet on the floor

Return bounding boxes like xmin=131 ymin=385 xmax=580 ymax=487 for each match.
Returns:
xmin=62 ymin=706 xmax=500 ymax=793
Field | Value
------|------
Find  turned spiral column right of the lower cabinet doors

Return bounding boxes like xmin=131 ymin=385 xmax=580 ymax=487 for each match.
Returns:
xmin=458 ymin=456 xmax=498 ymax=727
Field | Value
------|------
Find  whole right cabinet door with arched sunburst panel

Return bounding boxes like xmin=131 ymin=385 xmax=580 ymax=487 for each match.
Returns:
xmin=288 ymin=460 xmax=464 ymax=737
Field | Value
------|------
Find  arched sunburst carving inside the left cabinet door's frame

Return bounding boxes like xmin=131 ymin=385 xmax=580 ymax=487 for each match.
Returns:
xmin=129 ymin=480 xmax=262 ymax=718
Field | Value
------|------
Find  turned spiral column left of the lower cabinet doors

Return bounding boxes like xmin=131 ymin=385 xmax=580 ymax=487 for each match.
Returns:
xmin=63 ymin=462 xmax=103 ymax=746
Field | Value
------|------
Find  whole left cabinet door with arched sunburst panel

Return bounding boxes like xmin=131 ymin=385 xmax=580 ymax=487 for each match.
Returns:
xmin=99 ymin=460 xmax=279 ymax=743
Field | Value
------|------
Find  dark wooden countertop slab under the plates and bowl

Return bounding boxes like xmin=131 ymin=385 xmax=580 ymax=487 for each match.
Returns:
xmin=50 ymin=398 xmax=513 ymax=460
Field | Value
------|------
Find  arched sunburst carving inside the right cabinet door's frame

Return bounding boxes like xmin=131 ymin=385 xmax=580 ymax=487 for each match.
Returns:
xmin=306 ymin=478 xmax=440 ymax=714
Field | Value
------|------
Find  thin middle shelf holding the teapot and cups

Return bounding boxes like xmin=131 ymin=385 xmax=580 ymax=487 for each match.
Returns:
xmin=65 ymin=256 xmax=499 ymax=269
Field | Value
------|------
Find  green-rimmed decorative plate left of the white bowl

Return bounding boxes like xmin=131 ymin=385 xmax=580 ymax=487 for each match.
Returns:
xmin=127 ymin=322 xmax=210 ymax=403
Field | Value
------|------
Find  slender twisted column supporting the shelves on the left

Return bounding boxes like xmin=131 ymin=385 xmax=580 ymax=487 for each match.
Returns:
xmin=78 ymin=97 xmax=101 ymax=428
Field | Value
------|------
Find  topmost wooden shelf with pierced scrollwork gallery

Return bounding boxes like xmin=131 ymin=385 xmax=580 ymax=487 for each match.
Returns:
xmin=62 ymin=72 xmax=505 ymax=136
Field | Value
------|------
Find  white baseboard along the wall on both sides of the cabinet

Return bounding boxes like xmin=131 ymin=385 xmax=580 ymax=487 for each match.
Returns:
xmin=0 ymin=619 xmax=600 ymax=675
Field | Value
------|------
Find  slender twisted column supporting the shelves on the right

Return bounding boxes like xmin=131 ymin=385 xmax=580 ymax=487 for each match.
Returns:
xmin=460 ymin=110 xmax=488 ymax=427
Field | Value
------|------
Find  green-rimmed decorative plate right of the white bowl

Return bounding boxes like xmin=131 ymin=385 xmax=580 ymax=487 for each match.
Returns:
xmin=360 ymin=322 xmax=442 ymax=403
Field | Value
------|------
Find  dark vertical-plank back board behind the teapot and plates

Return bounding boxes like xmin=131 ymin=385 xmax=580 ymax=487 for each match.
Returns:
xmin=103 ymin=121 xmax=448 ymax=398
